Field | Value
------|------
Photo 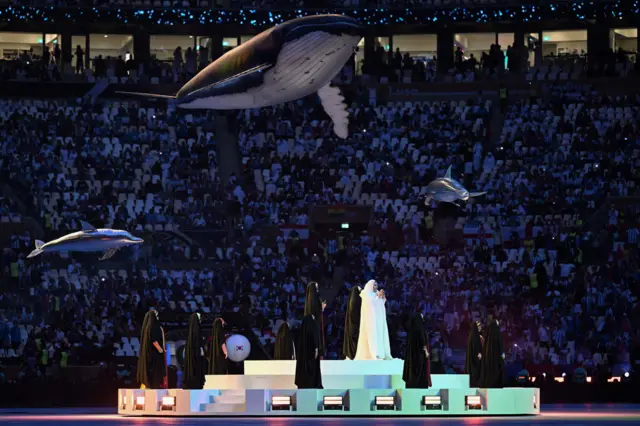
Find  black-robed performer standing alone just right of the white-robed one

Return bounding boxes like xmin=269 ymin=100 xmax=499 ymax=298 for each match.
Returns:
xmin=402 ymin=314 xmax=431 ymax=389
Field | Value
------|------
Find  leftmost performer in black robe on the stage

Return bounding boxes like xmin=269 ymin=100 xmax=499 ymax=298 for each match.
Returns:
xmin=137 ymin=310 xmax=167 ymax=389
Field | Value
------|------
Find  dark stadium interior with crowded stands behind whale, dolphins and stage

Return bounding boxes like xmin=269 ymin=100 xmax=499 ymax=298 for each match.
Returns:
xmin=0 ymin=0 xmax=640 ymax=425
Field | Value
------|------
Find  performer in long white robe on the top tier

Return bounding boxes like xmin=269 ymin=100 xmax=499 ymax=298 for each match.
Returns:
xmin=355 ymin=280 xmax=393 ymax=360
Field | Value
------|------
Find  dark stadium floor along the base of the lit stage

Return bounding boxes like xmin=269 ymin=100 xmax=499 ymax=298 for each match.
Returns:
xmin=0 ymin=404 xmax=640 ymax=426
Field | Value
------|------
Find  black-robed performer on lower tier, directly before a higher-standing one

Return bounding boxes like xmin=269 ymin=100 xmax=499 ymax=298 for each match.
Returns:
xmin=295 ymin=315 xmax=323 ymax=389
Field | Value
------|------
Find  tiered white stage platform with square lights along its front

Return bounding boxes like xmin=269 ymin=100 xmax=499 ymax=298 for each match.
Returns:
xmin=118 ymin=360 xmax=540 ymax=417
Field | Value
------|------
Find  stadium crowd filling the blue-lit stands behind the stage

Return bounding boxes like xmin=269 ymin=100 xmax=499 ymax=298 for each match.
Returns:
xmin=0 ymin=62 xmax=640 ymax=386
